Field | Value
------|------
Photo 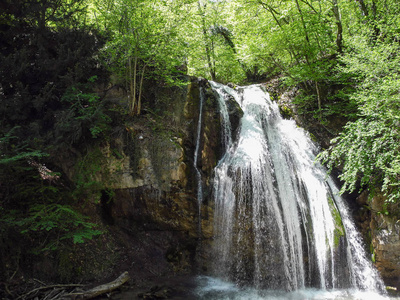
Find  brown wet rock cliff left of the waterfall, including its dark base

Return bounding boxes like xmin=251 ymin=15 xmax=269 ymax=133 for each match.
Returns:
xmin=82 ymin=78 xmax=223 ymax=275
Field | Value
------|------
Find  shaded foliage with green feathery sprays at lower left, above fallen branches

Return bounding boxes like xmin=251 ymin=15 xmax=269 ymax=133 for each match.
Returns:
xmin=0 ymin=161 xmax=100 ymax=254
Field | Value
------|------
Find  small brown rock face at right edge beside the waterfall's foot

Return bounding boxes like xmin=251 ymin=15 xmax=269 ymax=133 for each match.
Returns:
xmin=370 ymin=195 xmax=400 ymax=289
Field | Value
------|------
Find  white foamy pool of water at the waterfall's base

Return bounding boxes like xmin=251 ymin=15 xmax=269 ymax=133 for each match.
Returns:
xmin=194 ymin=276 xmax=400 ymax=300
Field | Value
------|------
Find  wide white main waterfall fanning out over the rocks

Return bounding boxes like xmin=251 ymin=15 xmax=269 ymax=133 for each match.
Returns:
xmin=208 ymin=82 xmax=384 ymax=292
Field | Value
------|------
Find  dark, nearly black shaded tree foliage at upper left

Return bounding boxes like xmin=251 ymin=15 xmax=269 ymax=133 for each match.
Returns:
xmin=0 ymin=25 xmax=109 ymax=152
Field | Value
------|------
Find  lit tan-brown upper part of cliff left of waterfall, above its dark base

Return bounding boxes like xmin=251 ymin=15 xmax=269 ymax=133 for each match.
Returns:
xmin=100 ymin=79 xmax=219 ymax=239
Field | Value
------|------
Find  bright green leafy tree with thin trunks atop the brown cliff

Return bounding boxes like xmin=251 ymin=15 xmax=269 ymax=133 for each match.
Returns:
xmin=96 ymin=0 xmax=192 ymax=115
